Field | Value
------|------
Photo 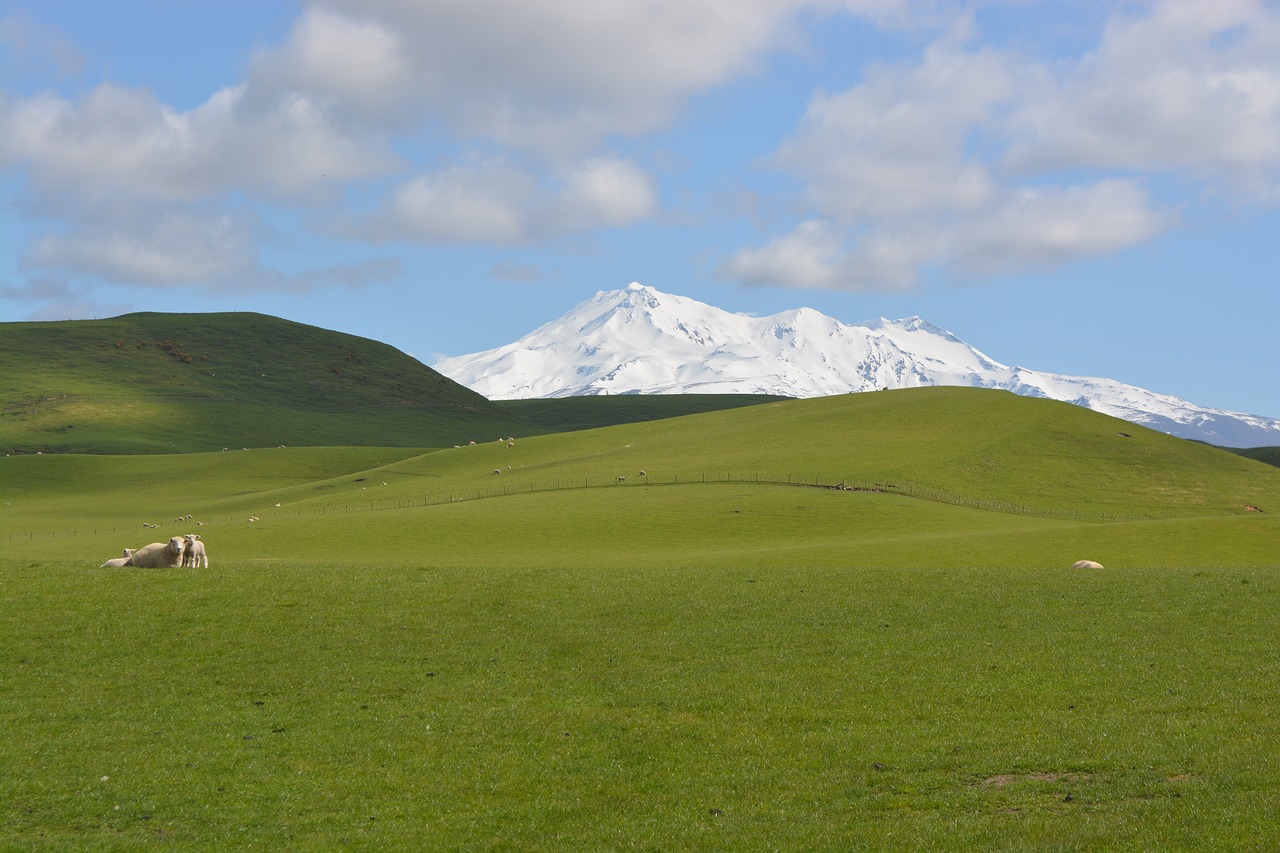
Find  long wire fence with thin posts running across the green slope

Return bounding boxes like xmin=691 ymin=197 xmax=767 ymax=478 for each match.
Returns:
xmin=6 ymin=470 xmax=1146 ymax=542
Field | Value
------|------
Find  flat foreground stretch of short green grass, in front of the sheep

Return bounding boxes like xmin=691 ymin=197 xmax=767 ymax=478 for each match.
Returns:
xmin=0 ymin=558 xmax=1280 ymax=849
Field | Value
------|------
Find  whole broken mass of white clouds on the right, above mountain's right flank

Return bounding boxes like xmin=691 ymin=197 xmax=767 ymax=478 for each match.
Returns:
xmin=719 ymin=0 xmax=1280 ymax=289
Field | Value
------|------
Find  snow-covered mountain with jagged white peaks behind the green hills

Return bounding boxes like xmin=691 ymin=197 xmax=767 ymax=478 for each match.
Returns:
xmin=433 ymin=283 xmax=1280 ymax=447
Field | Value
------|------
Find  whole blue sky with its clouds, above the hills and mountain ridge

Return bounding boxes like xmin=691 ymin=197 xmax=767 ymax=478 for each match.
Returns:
xmin=0 ymin=0 xmax=1280 ymax=416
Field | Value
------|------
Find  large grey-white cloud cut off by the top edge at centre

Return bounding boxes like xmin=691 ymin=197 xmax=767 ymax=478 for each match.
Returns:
xmin=311 ymin=0 xmax=839 ymax=159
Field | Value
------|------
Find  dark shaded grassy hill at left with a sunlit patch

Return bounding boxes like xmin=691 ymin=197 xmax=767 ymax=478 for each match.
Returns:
xmin=0 ymin=313 xmax=536 ymax=453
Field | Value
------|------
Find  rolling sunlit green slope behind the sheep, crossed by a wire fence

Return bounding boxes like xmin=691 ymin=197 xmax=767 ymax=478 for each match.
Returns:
xmin=0 ymin=388 xmax=1280 ymax=565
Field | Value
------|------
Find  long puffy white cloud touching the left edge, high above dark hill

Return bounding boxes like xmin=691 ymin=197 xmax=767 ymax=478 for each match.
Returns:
xmin=0 ymin=83 xmax=390 ymax=202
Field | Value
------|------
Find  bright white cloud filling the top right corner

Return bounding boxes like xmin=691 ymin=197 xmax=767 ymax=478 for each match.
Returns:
xmin=1007 ymin=0 xmax=1280 ymax=196
